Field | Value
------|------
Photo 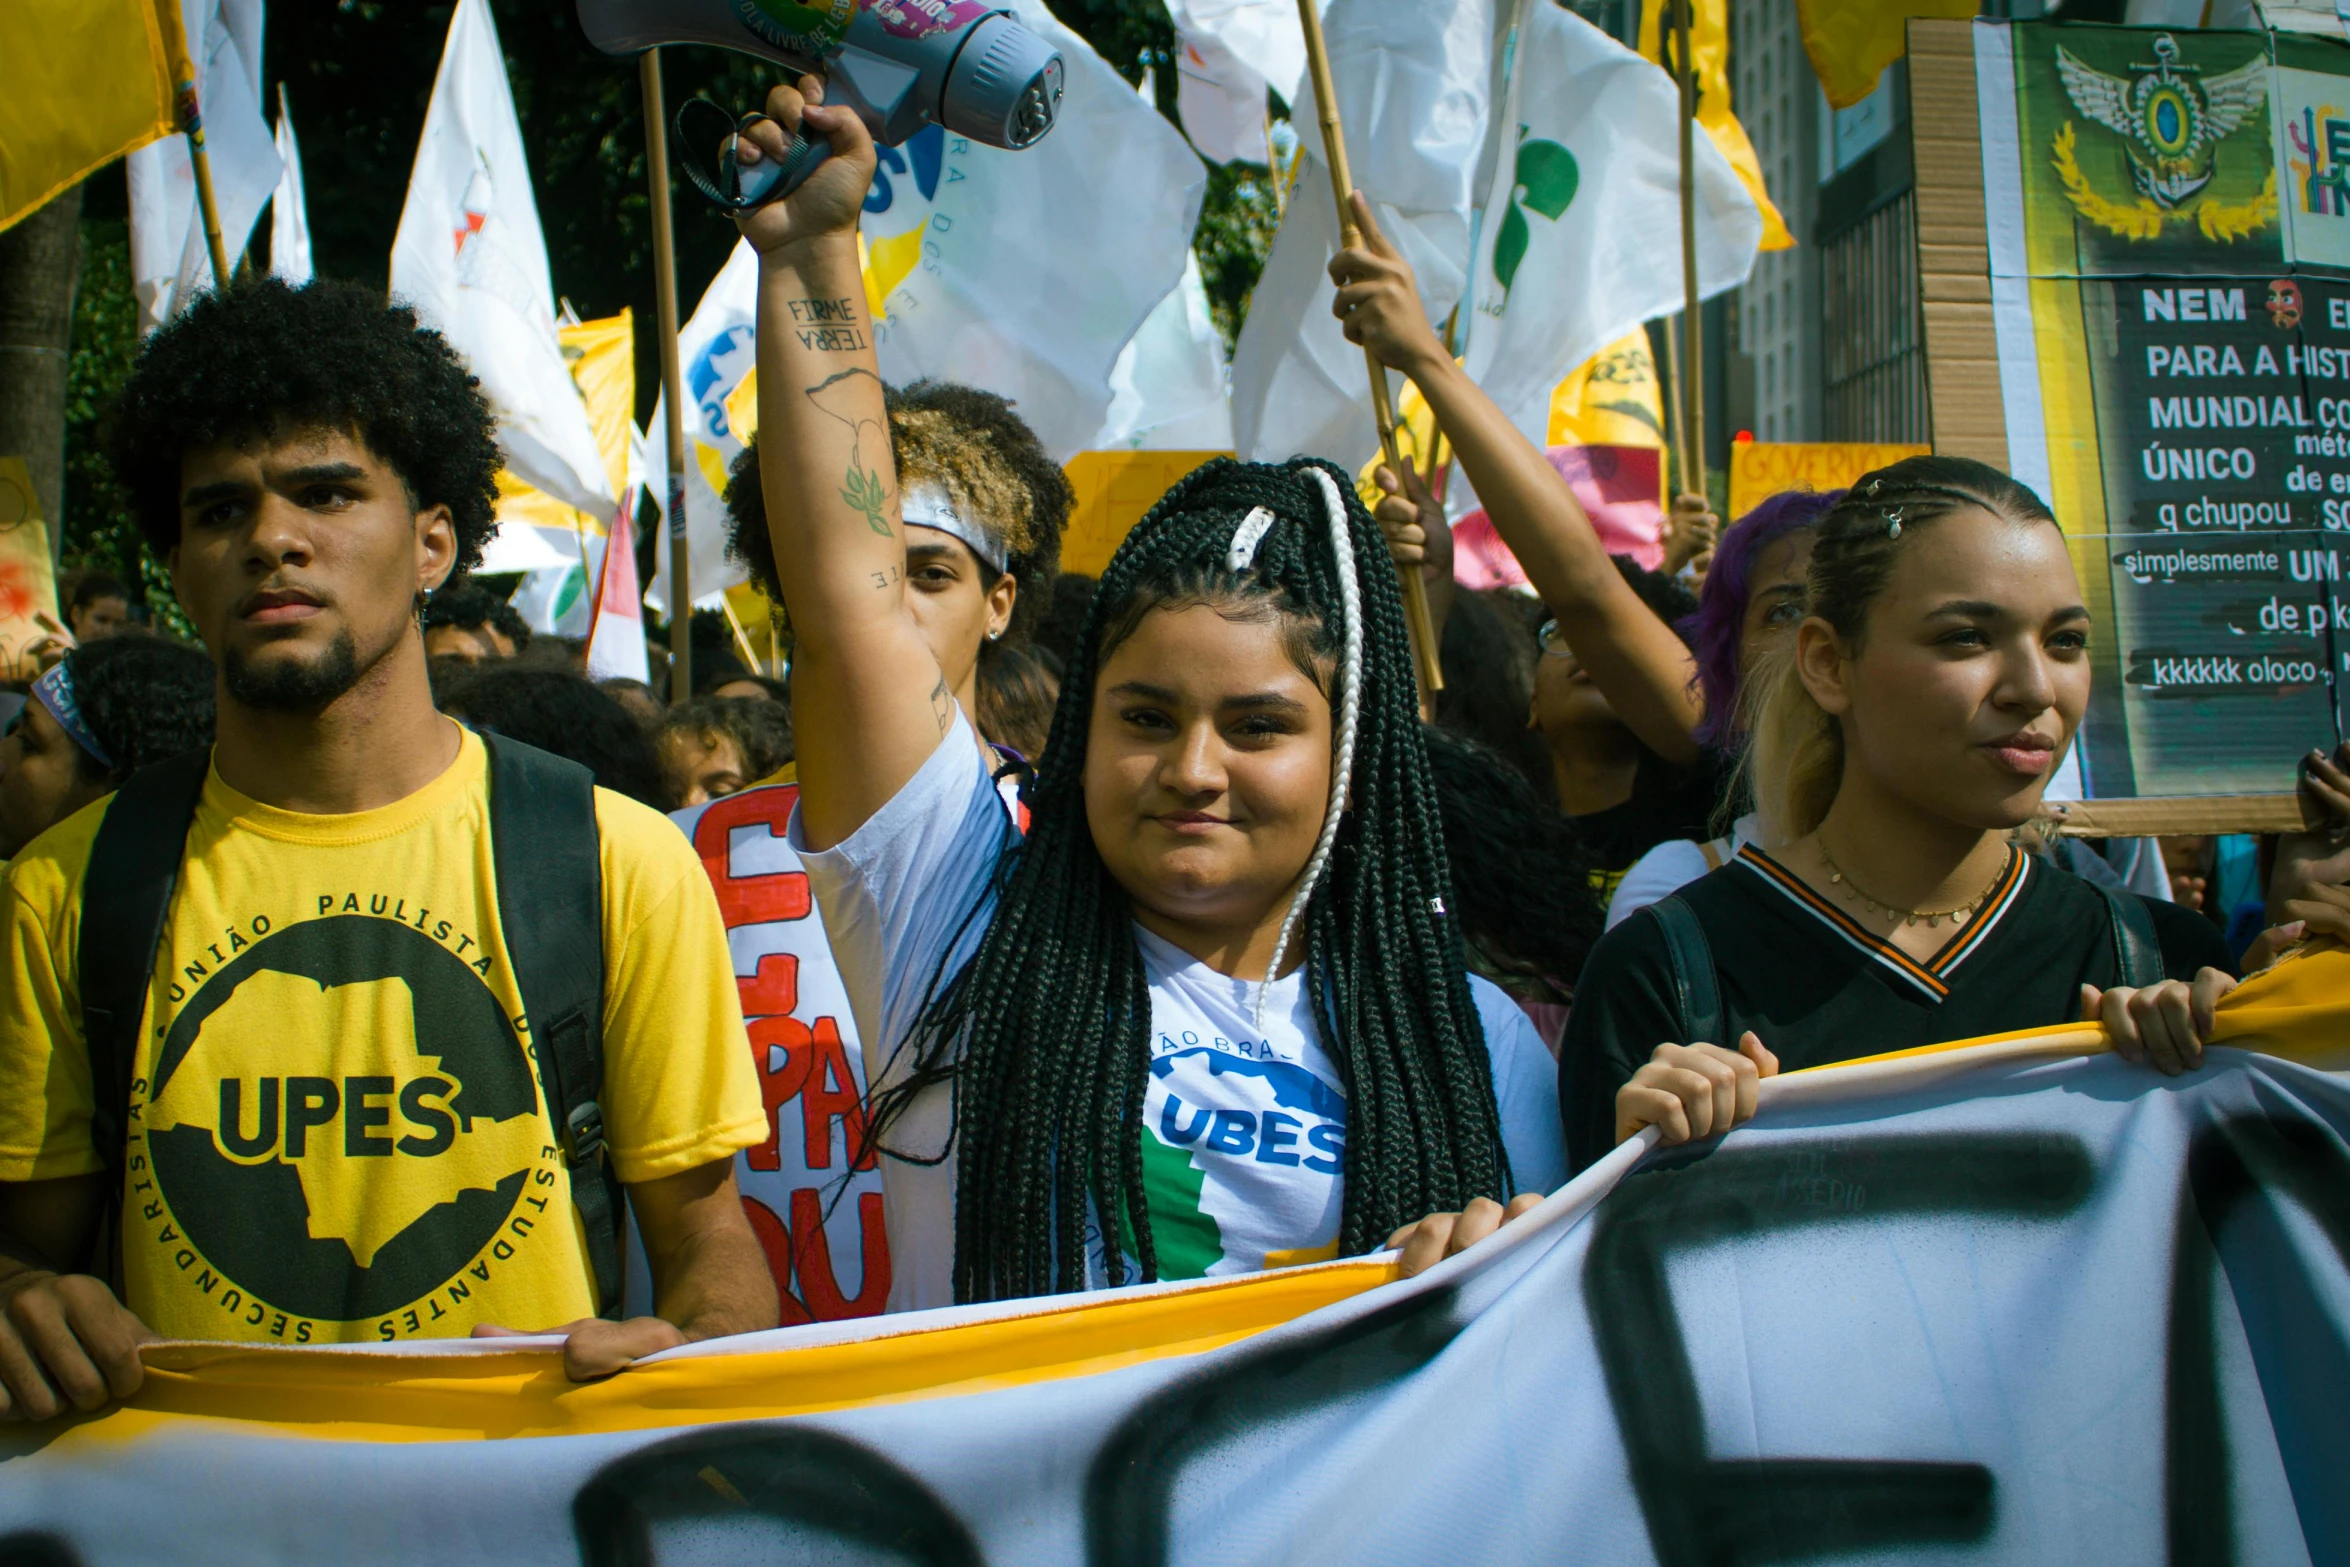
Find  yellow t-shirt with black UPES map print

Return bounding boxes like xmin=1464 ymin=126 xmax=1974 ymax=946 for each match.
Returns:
xmin=0 ymin=733 xmax=766 ymax=1344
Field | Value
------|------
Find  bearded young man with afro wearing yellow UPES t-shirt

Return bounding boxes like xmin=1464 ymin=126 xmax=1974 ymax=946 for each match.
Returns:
xmin=0 ymin=280 xmax=776 ymax=1419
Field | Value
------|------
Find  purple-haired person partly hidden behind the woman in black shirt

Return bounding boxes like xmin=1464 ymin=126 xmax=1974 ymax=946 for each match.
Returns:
xmin=1607 ymin=489 xmax=1845 ymax=930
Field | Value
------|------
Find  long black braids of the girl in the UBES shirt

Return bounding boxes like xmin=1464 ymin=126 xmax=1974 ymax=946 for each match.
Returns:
xmin=872 ymin=458 xmax=1509 ymax=1302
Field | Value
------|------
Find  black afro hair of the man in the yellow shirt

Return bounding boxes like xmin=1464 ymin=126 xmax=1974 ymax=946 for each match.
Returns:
xmin=106 ymin=277 xmax=501 ymax=571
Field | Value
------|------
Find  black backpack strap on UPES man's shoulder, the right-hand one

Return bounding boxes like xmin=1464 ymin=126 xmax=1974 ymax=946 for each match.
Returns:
xmin=482 ymin=733 xmax=625 ymax=1316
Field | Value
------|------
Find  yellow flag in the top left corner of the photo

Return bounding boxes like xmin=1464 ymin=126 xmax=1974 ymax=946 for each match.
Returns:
xmin=0 ymin=0 xmax=179 ymax=228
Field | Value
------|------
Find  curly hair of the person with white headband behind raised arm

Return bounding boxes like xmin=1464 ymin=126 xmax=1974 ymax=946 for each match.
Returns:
xmin=726 ymin=381 xmax=1076 ymax=644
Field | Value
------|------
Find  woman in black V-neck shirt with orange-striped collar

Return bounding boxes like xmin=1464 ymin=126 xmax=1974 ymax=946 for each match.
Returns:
xmin=1558 ymin=458 xmax=2233 ymax=1168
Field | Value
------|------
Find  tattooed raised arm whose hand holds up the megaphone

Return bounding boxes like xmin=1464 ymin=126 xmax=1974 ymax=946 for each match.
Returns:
xmin=740 ymin=78 xmax=954 ymax=848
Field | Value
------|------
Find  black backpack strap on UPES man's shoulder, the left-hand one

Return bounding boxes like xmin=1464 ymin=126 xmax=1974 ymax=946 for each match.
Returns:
xmin=73 ymin=745 xmax=212 ymax=1175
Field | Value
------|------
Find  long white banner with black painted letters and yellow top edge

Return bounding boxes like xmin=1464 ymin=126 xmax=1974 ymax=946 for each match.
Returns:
xmin=0 ymin=951 xmax=2350 ymax=1565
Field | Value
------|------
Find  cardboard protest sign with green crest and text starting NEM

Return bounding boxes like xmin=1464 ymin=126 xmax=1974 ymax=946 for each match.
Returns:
xmin=1911 ymin=23 xmax=2350 ymax=832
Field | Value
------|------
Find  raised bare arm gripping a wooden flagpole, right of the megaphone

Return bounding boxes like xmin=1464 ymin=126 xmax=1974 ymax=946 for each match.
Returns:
xmin=1330 ymin=193 xmax=1704 ymax=766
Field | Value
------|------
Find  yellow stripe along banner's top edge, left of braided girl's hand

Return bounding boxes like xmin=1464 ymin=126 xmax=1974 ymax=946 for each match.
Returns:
xmin=61 ymin=1259 xmax=1396 ymax=1442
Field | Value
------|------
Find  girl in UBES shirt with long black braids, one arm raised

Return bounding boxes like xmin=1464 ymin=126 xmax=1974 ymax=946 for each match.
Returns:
xmin=743 ymin=78 xmax=1563 ymax=1309
